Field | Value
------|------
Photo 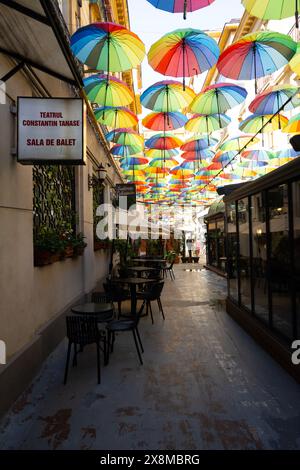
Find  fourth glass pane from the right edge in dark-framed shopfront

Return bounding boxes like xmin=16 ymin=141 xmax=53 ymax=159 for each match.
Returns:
xmin=238 ymin=198 xmax=251 ymax=310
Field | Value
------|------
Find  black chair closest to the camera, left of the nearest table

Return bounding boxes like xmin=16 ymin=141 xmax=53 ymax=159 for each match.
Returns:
xmin=64 ymin=315 xmax=107 ymax=385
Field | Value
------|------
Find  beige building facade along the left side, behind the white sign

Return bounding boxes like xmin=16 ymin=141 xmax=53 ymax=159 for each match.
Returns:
xmin=0 ymin=0 xmax=133 ymax=412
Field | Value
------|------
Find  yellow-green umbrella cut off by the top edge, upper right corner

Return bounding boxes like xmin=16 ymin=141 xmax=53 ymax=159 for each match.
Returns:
xmin=242 ymin=0 xmax=299 ymax=28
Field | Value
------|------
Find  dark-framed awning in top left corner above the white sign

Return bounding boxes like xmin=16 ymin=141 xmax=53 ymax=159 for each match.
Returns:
xmin=0 ymin=0 xmax=82 ymax=86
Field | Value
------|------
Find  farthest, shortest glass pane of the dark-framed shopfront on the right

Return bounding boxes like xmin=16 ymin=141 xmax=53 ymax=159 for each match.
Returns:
xmin=226 ymin=202 xmax=238 ymax=301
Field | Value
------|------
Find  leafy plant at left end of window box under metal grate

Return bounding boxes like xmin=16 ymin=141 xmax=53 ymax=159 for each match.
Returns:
xmin=34 ymin=227 xmax=65 ymax=266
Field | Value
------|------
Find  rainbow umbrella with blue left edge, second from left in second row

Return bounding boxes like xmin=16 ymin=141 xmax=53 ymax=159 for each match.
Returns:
xmin=141 ymin=80 xmax=196 ymax=113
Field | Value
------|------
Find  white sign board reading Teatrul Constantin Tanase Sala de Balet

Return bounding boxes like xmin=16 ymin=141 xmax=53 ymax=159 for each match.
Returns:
xmin=17 ymin=97 xmax=84 ymax=164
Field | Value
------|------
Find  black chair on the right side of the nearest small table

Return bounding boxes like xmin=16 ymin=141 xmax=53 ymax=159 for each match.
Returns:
xmin=106 ymin=314 xmax=144 ymax=365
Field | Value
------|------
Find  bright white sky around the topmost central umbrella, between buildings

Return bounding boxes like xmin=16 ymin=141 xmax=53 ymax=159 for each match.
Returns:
xmin=128 ymin=0 xmax=244 ymax=89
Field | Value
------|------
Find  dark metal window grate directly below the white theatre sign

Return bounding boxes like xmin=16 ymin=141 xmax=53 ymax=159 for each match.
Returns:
xmin=33 ymin=165 xmax=76 ymax=239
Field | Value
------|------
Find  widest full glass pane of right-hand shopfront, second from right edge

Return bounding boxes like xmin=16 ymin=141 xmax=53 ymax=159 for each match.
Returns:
xmin=267 ymin=184 xmax=293 ymax=338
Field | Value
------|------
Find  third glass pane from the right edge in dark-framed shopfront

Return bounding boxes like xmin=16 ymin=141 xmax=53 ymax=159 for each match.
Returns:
xmin=251 ymin=193 xmax=269 ymax=324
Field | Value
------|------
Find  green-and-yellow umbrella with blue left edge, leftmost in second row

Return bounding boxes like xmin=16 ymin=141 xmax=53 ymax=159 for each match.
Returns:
xmin=83 ymin=74 xmax=134 ymax=106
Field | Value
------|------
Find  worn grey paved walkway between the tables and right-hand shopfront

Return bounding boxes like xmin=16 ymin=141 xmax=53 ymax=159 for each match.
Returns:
xmin=0 ymin=265 xmax=300 ymax=450
